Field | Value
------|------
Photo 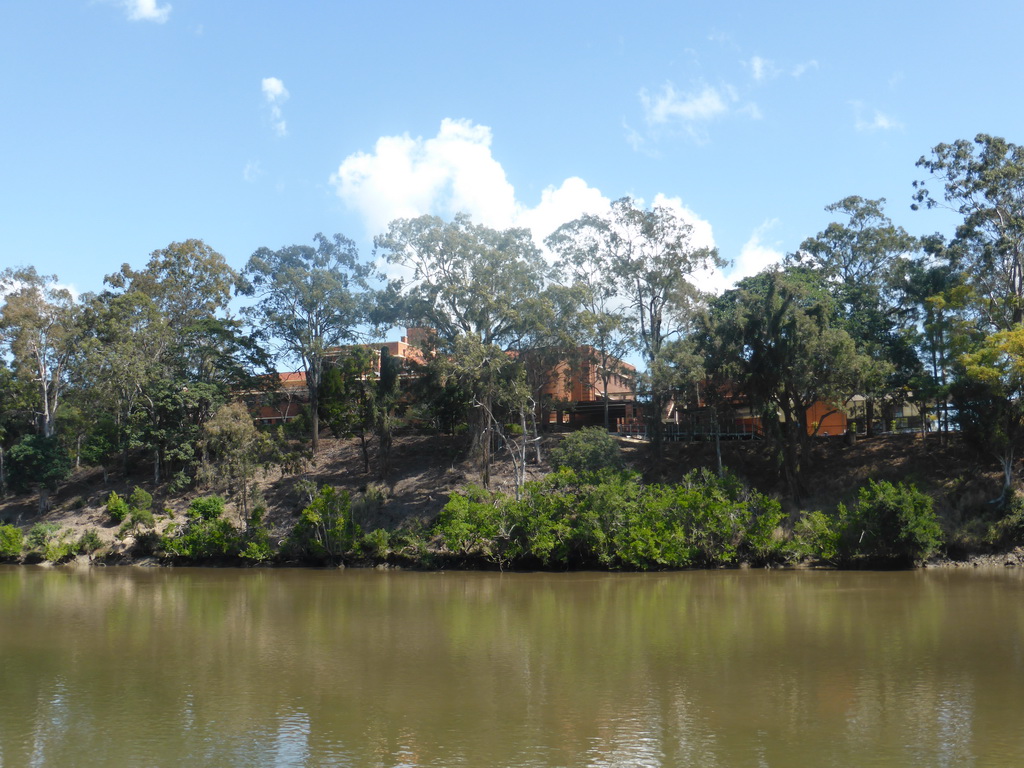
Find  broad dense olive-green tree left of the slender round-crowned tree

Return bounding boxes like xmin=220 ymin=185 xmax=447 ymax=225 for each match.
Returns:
xmin=92 ymin=240 xmax=269 ymax=484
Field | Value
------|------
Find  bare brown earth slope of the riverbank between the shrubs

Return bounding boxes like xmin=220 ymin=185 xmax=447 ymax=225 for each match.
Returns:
xmin=0 ymin=434 xmax=1024 ymax=567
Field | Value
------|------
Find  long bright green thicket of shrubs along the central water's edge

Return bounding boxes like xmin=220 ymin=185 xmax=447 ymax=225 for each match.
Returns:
xmin=434 ymin=468 xmax=785 ymax=569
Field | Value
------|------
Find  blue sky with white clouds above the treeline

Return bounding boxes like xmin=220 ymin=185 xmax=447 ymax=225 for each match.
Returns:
xmin=0 ymin=0 xmax=1024 ymax=291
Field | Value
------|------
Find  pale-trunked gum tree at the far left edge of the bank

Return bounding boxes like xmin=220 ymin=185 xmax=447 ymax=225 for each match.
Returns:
xmin=0 ymin=267 xmax=81 ymax=437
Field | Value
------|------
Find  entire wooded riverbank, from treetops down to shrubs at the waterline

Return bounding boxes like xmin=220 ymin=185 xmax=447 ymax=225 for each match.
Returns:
xmin=6 ymin=134 xmax=1024 ymax=570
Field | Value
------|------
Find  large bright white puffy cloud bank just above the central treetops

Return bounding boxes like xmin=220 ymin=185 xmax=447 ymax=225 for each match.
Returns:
xmin=331 ymin=119 xmax=782 ymax=293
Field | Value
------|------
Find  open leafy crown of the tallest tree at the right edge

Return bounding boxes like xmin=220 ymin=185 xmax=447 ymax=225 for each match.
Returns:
xmin=913 ymin=133 xmax=1024 ymax=333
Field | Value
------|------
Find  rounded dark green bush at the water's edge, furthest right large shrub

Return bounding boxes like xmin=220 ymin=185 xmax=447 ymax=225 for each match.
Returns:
xmin=840 ymin=480 xmax=942 ymax=562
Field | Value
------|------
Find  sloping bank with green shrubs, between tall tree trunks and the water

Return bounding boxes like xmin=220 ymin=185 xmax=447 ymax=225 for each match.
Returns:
xmin=0 ymin=429 xmax=1024 ymax=571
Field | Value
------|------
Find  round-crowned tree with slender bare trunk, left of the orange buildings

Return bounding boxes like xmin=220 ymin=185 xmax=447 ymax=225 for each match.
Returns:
xmin=242 ymin=233 xmax=376 ymax=454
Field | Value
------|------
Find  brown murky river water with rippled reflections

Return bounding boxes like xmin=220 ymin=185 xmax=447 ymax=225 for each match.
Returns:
xmin=0 ymin=567 xmax=1024 ymax=768
